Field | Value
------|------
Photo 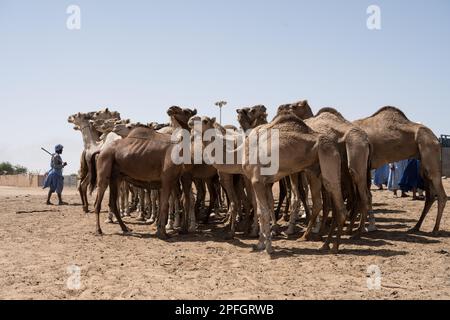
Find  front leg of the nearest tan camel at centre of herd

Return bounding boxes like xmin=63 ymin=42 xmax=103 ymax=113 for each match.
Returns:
xmin=253 ymin=182 xmax=273 ymax=254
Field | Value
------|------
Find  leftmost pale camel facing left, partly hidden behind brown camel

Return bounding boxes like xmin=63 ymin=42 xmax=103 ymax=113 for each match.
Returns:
xmin=67 ymin=108 xmax=120 ymax=213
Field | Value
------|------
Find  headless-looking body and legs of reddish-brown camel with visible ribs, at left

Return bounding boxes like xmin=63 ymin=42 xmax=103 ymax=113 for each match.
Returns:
xmin=91 ymin=124 xmax=192 ymax=239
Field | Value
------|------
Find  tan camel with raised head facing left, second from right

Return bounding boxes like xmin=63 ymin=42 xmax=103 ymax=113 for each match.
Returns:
xmin=278 ymin=100 xmax=370 ymax=238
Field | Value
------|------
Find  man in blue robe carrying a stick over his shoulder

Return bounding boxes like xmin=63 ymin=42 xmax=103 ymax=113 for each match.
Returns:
xmin=44 ymin=144 xmax=67 ymax=206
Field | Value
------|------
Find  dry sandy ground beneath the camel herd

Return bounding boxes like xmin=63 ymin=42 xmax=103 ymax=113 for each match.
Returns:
xmin=0 ymin=180 xmax=450 ymax=299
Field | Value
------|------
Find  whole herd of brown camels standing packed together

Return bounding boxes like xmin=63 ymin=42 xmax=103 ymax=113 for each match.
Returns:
xmin=68 ymin=100 xmax=447 ymax=254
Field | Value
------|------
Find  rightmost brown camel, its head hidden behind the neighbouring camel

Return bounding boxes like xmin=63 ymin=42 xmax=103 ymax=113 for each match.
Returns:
xmin=353 ymin=106 xmax=447 ymax=235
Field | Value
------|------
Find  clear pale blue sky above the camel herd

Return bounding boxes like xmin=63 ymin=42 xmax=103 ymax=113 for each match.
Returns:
xmin=0 ymin=0 xmax=450 ymax=173
